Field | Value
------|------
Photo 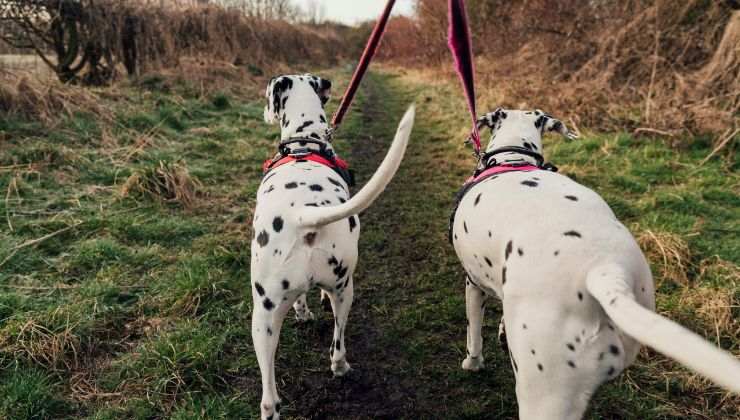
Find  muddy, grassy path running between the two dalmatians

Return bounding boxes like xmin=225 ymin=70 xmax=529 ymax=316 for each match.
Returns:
xmin=281 ymin=74 xmax=513 ymax=419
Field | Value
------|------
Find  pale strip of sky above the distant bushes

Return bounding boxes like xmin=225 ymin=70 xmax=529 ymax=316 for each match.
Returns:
xmin=295 ymin=0 xmax=416 ymax=25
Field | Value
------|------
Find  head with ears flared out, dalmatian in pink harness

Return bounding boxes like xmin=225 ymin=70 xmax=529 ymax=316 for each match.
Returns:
xmin=477 ymin=108 xmax=578 ymax=153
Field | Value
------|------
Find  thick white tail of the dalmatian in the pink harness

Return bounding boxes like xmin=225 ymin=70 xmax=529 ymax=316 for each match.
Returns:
xmin=586 ymin=265 xmax=740 ymax=393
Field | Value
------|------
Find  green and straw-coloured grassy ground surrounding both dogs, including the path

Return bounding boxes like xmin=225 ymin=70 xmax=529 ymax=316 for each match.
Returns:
xmin=0 ymin=67 xmax=740 ymax=419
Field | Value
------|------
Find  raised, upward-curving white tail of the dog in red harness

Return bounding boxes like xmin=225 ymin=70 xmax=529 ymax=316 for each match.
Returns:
xmin=295 ymin=105 xmax=416 ymax=227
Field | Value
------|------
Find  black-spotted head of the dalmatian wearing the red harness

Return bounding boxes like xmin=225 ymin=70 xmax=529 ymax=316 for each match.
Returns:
xmin=265 ymin=74 xmax=331 ymax=124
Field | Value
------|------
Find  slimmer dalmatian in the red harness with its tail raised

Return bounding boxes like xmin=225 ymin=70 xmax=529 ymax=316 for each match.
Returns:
xmin=250 ymin=74 xmax=415 ymax=420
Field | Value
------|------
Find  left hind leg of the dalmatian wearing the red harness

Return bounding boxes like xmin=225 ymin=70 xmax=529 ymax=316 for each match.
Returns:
xmin=252 ymin=283 xmax=292 ymax=420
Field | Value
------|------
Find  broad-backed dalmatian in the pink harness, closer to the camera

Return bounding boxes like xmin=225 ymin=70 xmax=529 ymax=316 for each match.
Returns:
xmin=451 ymin=109 xmax=740 ymax=420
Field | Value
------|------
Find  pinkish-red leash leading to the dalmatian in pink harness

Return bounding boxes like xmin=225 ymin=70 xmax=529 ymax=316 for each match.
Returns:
xmin=447 ymin=0 xmax=481 ymax=157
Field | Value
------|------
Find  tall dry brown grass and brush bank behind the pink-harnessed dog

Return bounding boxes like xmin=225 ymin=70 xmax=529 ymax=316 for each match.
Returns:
xmin=382 ymin=0 xmax=740 ymax=139
